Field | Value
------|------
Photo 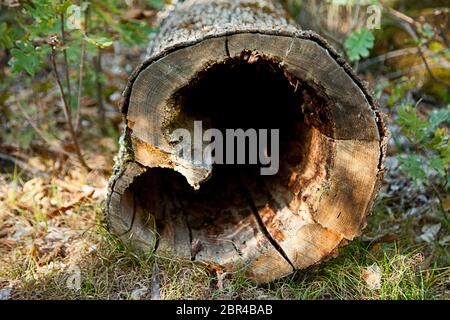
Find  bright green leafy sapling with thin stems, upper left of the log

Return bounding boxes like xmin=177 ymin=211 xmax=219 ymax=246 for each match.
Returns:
xmin=0 ymin=0 xmax=162 ymax=169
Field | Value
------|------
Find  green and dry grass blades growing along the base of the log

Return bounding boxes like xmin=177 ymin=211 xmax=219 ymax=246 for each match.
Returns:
xmin=0 ymin=184 xmax=450 ymax=300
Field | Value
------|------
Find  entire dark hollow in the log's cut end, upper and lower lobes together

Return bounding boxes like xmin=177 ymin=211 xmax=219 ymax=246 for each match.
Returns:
xmin=121 ymin=58 xmax=332 ymax=262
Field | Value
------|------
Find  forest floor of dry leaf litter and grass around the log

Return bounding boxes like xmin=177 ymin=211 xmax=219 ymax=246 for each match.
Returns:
xmin=0 ymin=2 xmax=450 ymax=300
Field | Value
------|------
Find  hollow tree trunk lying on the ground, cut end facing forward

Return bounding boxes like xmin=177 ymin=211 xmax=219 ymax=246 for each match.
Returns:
xmin=107 ymin=0 xmax=386 ymax=282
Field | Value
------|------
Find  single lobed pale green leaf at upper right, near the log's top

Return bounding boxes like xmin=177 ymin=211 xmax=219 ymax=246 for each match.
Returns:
xmin=344 ymin=28 xmax=375 ymax=61
